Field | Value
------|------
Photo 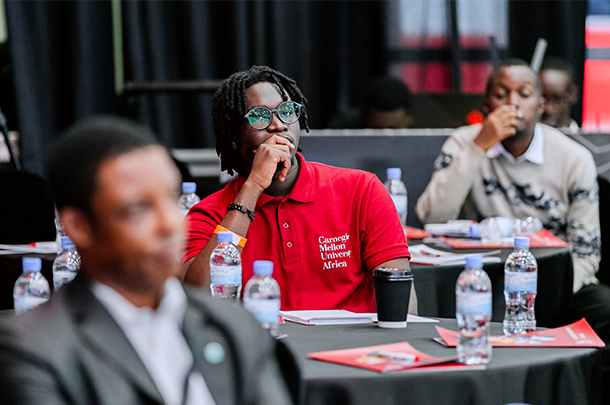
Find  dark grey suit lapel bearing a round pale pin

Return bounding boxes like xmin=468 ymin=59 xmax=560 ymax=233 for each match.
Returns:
xmin=183 ymin=291 xmax=239 ymax=404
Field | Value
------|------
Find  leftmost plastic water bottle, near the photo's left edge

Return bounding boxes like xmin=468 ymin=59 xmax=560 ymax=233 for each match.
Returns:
xmin=13 ymin=257 xmax=51 ymax=314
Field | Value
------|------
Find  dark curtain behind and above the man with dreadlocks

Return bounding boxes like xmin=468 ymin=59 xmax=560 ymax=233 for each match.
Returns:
xmin=118 ymin=0 xmax=384 ymax=147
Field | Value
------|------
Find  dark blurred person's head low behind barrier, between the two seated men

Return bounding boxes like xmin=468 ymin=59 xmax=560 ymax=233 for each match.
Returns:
xmin=329 ymin=77 xmax=413 ymax=129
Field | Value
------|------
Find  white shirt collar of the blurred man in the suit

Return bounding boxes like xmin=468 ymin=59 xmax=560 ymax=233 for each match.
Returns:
xmin=92 ymin=277 xmax=187 ymax=327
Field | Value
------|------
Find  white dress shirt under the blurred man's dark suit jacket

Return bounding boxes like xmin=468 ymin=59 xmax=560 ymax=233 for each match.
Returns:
xmin=93 ymin=277 xmax=214 ymax=405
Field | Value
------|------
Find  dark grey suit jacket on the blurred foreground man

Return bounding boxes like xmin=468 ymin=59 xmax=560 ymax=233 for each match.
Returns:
xmin=0 ymin=274 xmax=298 ymax=405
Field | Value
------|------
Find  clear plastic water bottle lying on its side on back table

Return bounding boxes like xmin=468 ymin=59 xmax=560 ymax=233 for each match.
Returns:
xmin=470 ymin=217 xmax=543 ymax=243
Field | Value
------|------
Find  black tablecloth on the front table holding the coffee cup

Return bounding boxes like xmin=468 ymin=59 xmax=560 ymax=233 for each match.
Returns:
xmin=280 ymin=319 xmax=602 ymax=405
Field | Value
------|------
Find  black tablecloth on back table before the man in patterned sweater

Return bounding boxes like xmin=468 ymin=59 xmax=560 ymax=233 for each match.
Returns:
xmin=411 ymin=243 xmax=573 ymax=327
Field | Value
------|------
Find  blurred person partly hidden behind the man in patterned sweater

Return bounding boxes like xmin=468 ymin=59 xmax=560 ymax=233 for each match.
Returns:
xmin=540 ymin=57 xmax=580 ymax=133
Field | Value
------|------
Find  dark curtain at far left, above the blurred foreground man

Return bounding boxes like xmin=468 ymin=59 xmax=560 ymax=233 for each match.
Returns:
xmin=5 ymin=0 xmax=116 ymax=174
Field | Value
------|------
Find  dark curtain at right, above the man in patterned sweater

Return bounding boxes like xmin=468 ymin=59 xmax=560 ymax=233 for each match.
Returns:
xmin=508 ymin=0 xmax=587 ymax=125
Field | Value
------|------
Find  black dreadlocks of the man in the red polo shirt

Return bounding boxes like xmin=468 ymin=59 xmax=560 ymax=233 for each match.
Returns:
xmin=211 ymin=66 xmax=309 ymax=175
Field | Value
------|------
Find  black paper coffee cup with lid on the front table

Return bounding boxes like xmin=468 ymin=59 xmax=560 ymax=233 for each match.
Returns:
xmin=373 ymin=267 xmax=413 ymax=328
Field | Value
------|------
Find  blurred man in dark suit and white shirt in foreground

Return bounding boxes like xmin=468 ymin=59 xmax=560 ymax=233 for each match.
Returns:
xmin=0 ymin=117 xmax=290 ymax=405
